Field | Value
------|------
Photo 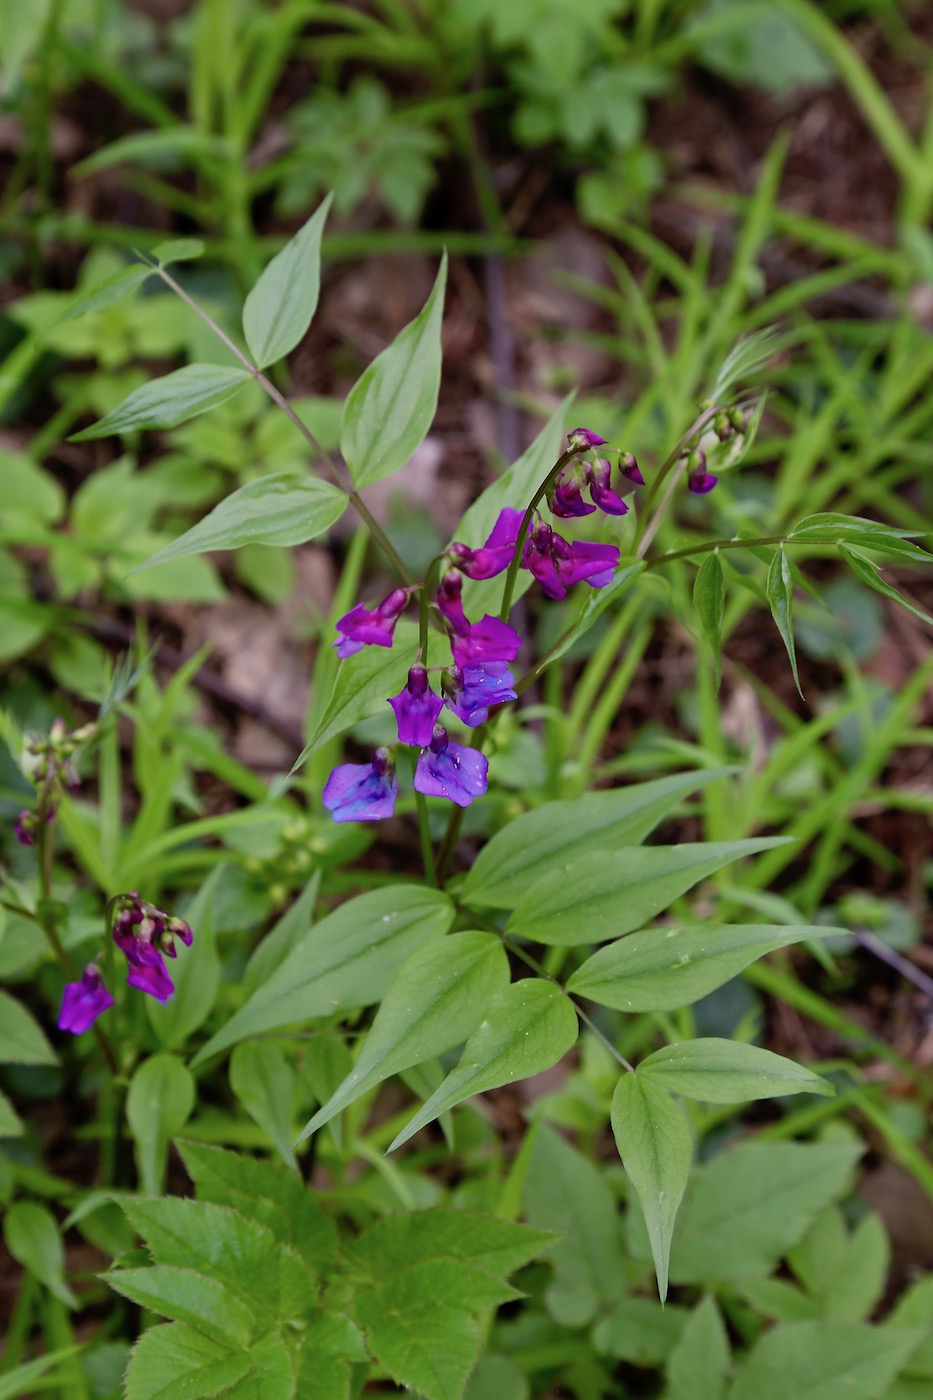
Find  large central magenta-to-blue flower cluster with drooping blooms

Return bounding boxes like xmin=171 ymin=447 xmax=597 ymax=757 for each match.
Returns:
xmin=322 ymin=428 xmax=644 ymax=822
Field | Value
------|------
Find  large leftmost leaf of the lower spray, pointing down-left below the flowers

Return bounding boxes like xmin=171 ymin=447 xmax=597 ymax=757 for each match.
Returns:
xmin=192 ymin=885 xmax=454 ymax=1064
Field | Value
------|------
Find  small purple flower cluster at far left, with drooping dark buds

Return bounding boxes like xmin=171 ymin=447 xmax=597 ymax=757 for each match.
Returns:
xmin=59 ymin=890 xmax=193 ymax=1036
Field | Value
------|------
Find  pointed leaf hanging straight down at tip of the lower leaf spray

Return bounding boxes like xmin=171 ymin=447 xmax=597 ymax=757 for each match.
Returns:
xmin=611 ymin=1070 xmax=693 ymax=1302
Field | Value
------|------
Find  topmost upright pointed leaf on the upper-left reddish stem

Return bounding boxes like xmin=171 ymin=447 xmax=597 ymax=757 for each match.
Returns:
xmin=242 ymin=195 xmax=333 ymax=370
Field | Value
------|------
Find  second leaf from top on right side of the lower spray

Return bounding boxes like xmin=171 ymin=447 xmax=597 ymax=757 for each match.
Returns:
xmin=507 ymin=836 xmax=783 ymax=946
